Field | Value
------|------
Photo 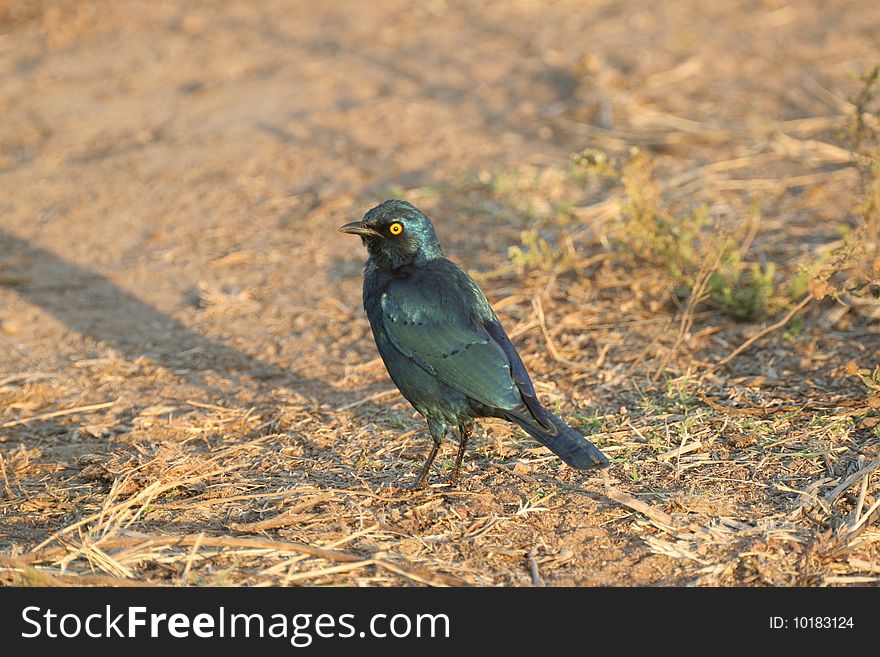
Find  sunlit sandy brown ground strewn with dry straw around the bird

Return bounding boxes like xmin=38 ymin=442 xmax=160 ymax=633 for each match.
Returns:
xmin=0 ymin=0 xmax=880 ymax=585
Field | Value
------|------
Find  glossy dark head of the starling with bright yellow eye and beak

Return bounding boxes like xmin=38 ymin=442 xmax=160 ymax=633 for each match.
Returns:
xmin=339 ymin=200 xmax=443 ymax=269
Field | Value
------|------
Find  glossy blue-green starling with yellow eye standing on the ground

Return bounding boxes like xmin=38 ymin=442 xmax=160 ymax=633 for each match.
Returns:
xmin=339 ymin=200 xmax=608 ymax=488
